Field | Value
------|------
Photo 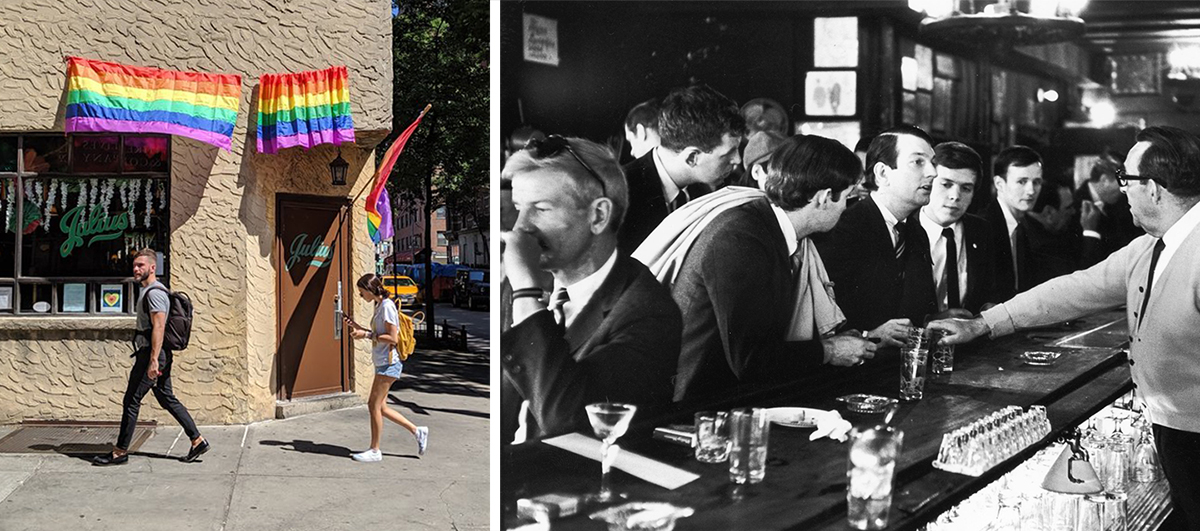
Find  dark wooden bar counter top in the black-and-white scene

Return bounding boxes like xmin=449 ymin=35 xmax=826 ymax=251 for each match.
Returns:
xmin=500 ymin=311 xmax=1132 ymax=531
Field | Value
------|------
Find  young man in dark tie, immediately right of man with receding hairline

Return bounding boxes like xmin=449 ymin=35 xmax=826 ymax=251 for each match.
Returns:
xmin=920 ymin=142 xmax=998 ymax=315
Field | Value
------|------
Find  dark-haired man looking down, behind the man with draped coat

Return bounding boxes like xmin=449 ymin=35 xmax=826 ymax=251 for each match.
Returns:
xmin=619 ymin=85 xmax=745 ymax=253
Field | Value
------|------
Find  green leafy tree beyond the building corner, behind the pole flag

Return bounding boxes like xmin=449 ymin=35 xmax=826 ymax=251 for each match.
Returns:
xmin=391 ymin=0 xmax=490 ymax=233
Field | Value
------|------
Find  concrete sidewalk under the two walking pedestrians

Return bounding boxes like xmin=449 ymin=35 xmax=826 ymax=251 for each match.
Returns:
xmin=0 ymin=351 xmax=490 ymax=531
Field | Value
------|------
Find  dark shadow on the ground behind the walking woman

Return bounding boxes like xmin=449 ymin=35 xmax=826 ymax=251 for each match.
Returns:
xmin=391 ymin=351 xmax=491 ymax=398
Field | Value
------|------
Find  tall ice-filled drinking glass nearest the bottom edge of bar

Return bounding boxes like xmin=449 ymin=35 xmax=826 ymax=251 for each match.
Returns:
xmin=846 ymin=425 xmax=904 ymax=530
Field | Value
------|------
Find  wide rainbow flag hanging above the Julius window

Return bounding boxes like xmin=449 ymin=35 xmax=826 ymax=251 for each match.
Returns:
xmin=65 ymin=58 xmax=241 ymax=150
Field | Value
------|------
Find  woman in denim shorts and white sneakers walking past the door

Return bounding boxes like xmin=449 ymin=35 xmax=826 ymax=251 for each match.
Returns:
xmin=346 ymin=273 xmax=430 ymax=463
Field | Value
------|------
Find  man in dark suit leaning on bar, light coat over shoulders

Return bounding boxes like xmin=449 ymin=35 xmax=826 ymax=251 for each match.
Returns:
xmin=671 ymin=136 xmax=875 ymax=400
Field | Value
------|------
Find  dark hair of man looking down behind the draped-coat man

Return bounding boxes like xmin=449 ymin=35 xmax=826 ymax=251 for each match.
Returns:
xmin=659 ymin=85 xmax=746 ymax=153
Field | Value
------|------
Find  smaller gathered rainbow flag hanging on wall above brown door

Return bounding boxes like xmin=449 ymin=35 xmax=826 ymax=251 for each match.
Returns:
xmin=258 ymin=66 xmax=354 ymax=153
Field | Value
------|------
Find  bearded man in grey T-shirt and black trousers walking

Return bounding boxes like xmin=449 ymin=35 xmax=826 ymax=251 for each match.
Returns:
xmin=91 ymin=249 xmax=209 ymax=466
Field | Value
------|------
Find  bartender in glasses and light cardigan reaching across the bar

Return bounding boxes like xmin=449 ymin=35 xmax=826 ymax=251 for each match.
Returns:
xmin=930 ymin=126 xmax=1200 ymax=530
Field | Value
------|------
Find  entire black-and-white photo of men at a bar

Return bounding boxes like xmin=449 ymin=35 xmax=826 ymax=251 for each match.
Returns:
xmin=493 ymin=0 xmax=1200 ymax=531
